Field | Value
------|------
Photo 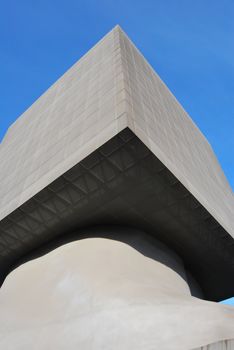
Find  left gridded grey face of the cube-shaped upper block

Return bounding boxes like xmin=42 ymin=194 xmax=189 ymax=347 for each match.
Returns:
xmin=0 ymin=29 xmax=126 ymax=219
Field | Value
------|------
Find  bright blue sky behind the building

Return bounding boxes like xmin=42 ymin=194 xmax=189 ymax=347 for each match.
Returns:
xmin=0 ymin=0 xmax=234 ymax=304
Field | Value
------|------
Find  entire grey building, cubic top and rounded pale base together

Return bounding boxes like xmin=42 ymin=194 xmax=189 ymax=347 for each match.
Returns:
xmin=0 ymin=26 xmax=234 ymax=350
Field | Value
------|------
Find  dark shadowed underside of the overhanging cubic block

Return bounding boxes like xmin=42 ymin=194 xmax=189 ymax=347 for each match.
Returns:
xmin=0 ymin=128 xmax=234 ymax=300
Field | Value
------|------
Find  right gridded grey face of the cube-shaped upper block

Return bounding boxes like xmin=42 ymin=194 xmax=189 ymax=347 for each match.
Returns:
xmin=116 ymin=30 xmax=234 ymax=235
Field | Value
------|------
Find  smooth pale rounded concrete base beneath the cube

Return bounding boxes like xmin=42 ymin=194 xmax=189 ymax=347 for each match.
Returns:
xmin=0 ymin=232 xmax=234 ymax=350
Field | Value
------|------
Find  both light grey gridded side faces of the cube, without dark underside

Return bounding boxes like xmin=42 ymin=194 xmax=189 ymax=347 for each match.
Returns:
xmin=0 ymin=26 xmax=234 ymax=237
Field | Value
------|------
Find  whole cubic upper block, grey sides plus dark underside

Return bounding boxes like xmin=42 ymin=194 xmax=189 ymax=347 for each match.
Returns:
xmin=0 ymin=27 xmax=234 ymax=300
